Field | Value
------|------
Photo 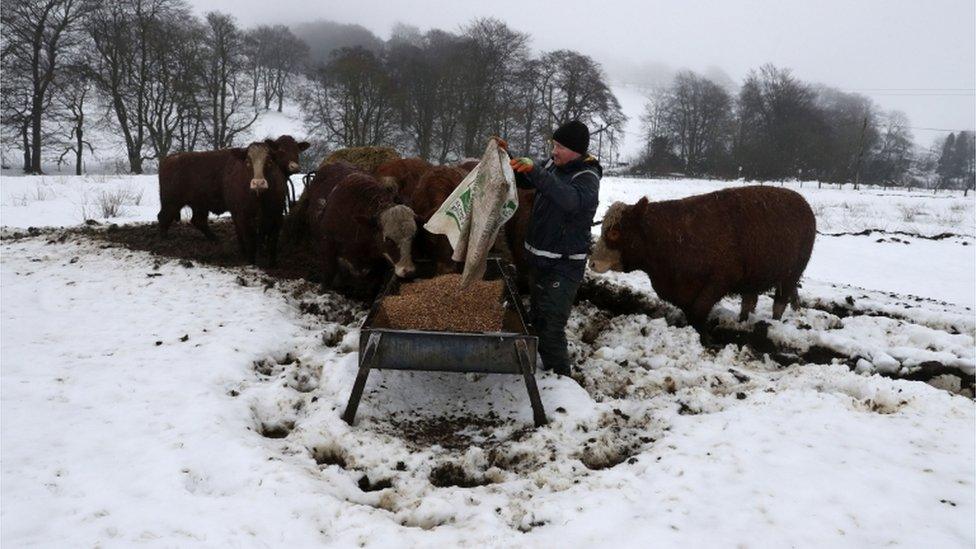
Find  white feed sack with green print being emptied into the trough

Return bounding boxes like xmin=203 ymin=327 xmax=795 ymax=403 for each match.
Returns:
xmin=424 ymin=139 xmax=518 ymax=288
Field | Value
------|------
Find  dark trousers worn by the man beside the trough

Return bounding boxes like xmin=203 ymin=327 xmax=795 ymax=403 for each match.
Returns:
xmin=529 ymin=269 xmax=580 ymax=376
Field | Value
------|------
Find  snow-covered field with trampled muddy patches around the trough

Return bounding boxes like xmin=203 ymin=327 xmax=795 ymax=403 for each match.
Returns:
xmin=0 ymin=176 xmax=976 ymax=547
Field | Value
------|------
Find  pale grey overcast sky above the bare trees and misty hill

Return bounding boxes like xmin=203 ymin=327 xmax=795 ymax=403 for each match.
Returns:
xmin=191 ymin=0 xmax=976 ymax=145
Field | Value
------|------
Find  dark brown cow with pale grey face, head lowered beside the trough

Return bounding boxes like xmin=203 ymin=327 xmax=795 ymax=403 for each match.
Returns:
xmin=308 ymin=173 xmax=417 ymax=294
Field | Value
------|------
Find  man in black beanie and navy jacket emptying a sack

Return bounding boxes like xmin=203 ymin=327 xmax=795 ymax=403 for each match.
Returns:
xmin=510 ymin=120 xmax=603 ymax=376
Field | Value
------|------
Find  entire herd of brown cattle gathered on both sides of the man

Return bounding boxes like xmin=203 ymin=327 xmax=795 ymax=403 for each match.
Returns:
xmin=158 ymin=135 xmax=816 ymax=337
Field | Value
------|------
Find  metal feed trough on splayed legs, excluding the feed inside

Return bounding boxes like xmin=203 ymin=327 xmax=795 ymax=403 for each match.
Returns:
xmin=342 ymin=258 xmax=547 ymax=427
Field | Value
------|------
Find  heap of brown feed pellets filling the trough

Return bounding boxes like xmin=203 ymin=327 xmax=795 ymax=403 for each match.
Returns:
xmin=377 ymin=274 xmax=505 ymax=332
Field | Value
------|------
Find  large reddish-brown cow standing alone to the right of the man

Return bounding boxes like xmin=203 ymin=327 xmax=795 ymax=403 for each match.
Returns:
xmin=590 ymin=186 xmax=817 ymax=341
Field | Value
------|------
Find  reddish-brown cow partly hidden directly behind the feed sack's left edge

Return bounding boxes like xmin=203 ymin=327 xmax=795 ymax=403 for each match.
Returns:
xmin=409 ymin=166 xmax=465 ymax=273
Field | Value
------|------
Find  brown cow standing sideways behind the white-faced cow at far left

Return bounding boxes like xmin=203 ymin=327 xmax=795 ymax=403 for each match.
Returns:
xmin=156 ymin=135 xmax=308 ymax=240
